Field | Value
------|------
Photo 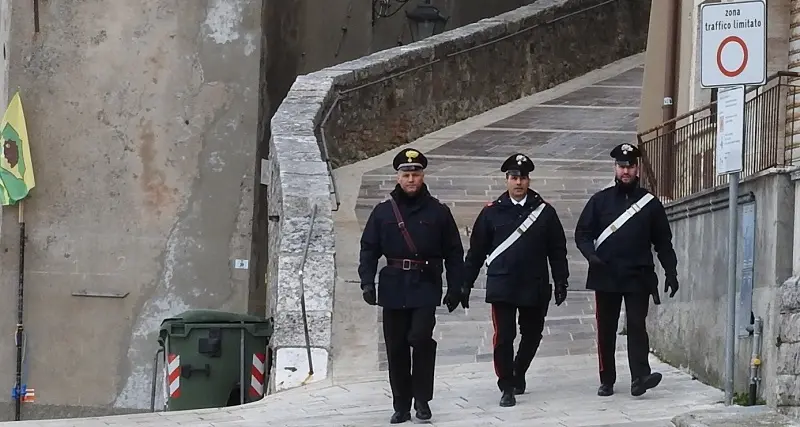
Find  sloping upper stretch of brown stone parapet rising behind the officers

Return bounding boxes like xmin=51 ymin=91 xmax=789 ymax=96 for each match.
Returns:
xmin=324 ymin=0 xmax=650 ymax=167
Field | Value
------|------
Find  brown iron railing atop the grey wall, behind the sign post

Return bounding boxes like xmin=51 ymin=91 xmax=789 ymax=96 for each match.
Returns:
xmin=637 ymin=72 xmax=800 ymax=201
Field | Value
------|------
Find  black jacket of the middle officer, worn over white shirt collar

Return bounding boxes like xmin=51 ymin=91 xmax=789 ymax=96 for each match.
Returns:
xmin=464 ymin=190 xmax=569 ymax=306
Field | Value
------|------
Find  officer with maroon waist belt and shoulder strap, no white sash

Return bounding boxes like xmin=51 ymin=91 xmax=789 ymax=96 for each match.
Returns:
xmin=358 ymin=148 xmax=469 ymax=424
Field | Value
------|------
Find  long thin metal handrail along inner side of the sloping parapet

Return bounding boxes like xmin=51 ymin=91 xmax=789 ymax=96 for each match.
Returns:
xmin=317 ymin=0 xmax=620 ymax=211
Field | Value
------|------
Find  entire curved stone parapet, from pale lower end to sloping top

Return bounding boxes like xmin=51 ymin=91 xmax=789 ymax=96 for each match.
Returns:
xmin=267 ymin=0 xmax=650 ymax=390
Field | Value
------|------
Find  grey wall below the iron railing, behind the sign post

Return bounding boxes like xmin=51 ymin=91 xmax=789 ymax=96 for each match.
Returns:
xmin=648 ymin=170 xmax=800 ymax=405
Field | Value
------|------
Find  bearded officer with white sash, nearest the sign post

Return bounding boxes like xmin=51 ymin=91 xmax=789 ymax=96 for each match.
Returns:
xmin=575 ymin=144 xmax=678 ymax=396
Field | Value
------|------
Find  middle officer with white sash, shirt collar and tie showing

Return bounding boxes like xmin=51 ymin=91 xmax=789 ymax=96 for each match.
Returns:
xmin=464 ymin=154 xmax=569 ymax=407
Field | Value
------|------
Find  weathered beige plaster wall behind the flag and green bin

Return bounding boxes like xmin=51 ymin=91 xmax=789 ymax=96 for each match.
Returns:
xmin=0 ymin=0 xmax=261 ymax=418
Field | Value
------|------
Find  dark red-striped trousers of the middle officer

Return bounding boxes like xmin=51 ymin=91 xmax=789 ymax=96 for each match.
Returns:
xmin=492 ymin=303 xmax=547 ymax=391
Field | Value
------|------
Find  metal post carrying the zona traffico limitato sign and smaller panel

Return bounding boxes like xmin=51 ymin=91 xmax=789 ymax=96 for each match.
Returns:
xmin=700 ymin=0 xmax=767 ymax=405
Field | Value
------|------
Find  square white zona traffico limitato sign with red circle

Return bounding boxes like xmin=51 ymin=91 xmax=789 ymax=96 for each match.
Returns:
xmin=700 ymin=0 xmax=767 ymax=88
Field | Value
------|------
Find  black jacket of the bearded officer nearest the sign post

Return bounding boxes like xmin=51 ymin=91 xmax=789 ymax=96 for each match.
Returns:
xmin=575 ymin=186 xmax=678 ymax=292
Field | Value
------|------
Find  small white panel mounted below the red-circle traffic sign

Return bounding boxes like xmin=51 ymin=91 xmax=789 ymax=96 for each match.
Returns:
xmin=716 ymin=86 xmax=744 ymax=175
